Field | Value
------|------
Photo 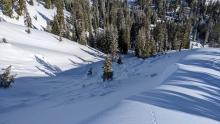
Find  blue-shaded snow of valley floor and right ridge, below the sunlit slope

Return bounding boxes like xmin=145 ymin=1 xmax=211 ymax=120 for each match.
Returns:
xmin=0 ymin=42 xmax=220 ymax=124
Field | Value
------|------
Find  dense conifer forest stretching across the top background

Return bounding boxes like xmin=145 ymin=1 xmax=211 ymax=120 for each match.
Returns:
xmin=1 ymin=0 xmax=220 ymax=55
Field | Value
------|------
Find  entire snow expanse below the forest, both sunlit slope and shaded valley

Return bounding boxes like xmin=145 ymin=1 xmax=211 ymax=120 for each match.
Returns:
xmin=0 ymin=22 xmax=220 ymax=124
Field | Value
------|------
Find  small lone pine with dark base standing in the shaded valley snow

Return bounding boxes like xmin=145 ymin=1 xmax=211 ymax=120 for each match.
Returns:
xmin=103 ymin=56 xmax=113 ymax=81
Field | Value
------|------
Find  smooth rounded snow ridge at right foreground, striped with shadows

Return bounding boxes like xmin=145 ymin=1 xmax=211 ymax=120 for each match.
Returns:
xmin=87 ymin=49 xmax=220 ymax=124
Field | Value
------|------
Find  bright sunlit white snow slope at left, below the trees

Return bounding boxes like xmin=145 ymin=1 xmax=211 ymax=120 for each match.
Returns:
xmin=0 ymin=22 xmax=101 ymax=77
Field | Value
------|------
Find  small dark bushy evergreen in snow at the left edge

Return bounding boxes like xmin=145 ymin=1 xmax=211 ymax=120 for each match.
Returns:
xmin=0 ymin=66 xmax=15 ymax=88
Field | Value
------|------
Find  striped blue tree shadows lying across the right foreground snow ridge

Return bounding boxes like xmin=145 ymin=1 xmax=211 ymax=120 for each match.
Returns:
xmin=129 ymin=60 xmax=220 ymax=121
